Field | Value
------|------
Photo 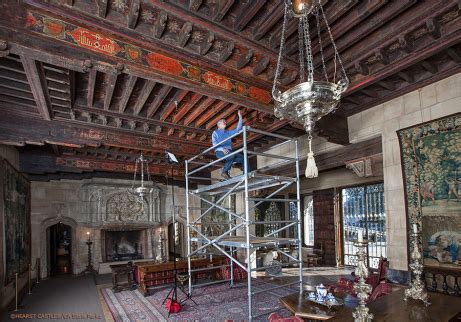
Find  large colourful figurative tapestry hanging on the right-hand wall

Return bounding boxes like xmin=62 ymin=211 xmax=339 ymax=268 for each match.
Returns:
xmin=398 ymin=114 xmax=461 ymax=269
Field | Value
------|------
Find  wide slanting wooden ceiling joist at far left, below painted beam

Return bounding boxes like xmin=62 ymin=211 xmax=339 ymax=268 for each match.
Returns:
xmin=21 ymin=55 xmax=51 ymax=120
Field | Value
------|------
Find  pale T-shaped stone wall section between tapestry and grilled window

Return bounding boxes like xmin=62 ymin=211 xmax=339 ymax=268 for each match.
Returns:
xmin=356 ymin=74 xmax=461 ymax=270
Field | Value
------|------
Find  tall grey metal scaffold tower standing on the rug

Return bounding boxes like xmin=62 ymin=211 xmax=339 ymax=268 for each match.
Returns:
xmin=185 ymin=127 xmax=303 ymax=321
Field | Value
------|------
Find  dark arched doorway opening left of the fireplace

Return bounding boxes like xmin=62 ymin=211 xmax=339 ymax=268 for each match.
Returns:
xmin=46 ymin=222 xmax=72 ymax=275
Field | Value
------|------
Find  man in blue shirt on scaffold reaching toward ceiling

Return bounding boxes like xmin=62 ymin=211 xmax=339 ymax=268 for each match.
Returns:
xmin=211 ymin=110 xmax=251 ymax=179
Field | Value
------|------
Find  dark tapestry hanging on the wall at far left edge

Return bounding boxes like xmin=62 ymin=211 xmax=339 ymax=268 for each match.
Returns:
xmin=0 ymin=159 xmax=30 ymax=284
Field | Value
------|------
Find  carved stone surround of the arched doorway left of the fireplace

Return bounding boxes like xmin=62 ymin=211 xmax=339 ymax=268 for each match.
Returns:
xmin=40 ymin=216 xmax=78 ymax=278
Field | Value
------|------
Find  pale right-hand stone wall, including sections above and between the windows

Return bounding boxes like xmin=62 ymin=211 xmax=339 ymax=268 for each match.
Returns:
xmin=258 ymin=73 xmax=461 ymax=270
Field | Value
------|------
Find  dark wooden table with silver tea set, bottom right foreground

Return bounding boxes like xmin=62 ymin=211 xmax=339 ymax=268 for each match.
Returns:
xmin=280 ymin=288 xmax=461 ymax=322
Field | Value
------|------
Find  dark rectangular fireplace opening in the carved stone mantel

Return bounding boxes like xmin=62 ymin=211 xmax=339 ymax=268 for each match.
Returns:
xmin=104 ymin=230 xmax=145 ymax=262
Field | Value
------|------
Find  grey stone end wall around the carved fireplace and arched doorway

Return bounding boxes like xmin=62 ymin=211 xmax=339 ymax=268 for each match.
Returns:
xmin=31 ymin=178 xmax=199 ymax=278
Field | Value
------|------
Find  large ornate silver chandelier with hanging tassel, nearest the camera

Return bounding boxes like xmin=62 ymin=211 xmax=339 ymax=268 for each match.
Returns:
xmin=272 ymin=0 xmax=349 ymax=178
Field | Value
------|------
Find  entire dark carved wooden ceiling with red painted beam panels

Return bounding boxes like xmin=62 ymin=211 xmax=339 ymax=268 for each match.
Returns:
xmin=0 ymin=0 xmax=461 ymax=179
